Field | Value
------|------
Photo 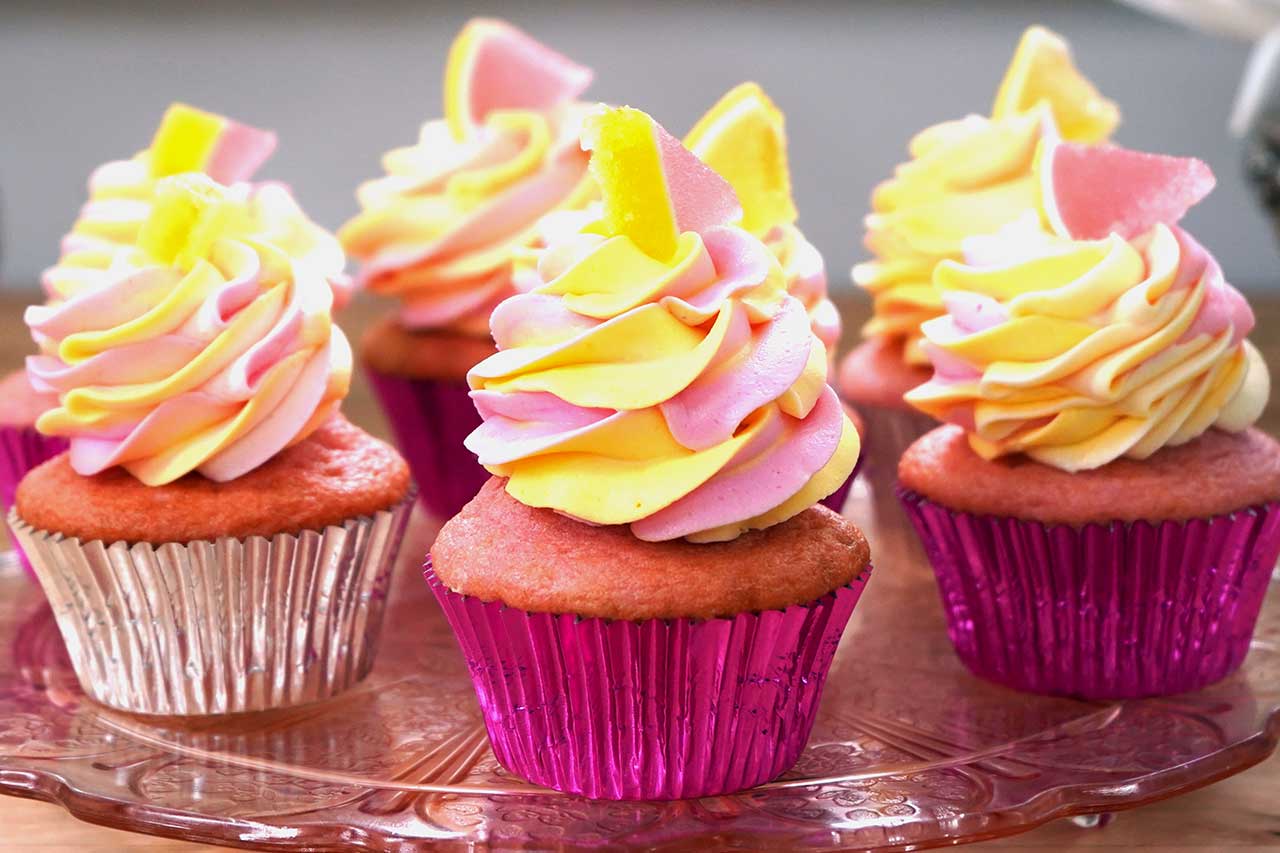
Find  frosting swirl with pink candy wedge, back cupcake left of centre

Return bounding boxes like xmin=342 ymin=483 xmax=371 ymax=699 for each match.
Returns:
xmin=339 ymin=19 xmax=593 ymax=334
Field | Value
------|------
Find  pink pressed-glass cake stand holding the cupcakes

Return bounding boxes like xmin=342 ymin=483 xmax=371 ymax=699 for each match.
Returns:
xmin=0 ymin=473 xmax=1280 ymax=850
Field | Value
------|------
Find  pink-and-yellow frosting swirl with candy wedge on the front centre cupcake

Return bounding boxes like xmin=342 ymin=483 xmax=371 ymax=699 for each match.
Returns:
xmin=467 ymin=108 xmax=859 ymax=540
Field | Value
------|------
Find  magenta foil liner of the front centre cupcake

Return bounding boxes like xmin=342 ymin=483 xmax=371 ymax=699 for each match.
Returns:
xmin=424 ymin=557 xmax=870 ymax=799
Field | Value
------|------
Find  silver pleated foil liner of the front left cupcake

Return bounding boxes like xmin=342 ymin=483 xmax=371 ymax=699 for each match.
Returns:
xmin=9 ymin=492 xmax=413 ymax=716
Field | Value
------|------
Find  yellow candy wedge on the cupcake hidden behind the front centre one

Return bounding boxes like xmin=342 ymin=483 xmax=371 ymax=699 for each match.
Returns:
xmin=685 ymin=83 xmax=796 ymax=234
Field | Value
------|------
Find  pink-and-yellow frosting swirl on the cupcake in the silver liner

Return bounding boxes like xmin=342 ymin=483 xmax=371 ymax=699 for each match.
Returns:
xmin=26 ymin=173 xmax=351 ymax=485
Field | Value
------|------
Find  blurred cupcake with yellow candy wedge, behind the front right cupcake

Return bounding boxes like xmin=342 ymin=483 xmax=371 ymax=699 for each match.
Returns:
xmin=840 ymin=27 xmax=1119 ymax=471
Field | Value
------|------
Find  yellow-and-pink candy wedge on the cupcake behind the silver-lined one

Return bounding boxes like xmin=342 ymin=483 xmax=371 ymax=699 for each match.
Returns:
xmin=151 ymin=104 xmax=275 ymax=183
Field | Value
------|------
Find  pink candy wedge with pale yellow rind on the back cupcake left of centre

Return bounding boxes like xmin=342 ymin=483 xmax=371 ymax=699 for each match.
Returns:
xmin=444 ymin=18 xmax=591 ymax=140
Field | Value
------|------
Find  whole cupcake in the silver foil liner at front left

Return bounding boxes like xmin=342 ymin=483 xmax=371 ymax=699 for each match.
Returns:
xmin=9 ymin=108 xmax=412 ymax=716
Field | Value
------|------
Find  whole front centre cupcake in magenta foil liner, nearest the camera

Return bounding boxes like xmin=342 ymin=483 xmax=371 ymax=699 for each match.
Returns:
xmin=426 ymin=108 xmax=870 ymax=799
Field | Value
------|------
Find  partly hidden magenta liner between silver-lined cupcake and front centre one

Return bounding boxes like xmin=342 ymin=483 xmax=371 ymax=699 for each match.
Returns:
xmin=366 ymin=368 xmax=490 ymax=520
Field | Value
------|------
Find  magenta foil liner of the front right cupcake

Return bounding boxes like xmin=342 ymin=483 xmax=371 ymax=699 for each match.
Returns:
xmin=899 ymin=489 xmax=1280 ymax=699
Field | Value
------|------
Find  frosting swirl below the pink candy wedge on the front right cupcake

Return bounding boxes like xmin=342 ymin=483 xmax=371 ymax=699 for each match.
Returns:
xmin=906 ymin=208 xmax=1270 ymax=471
